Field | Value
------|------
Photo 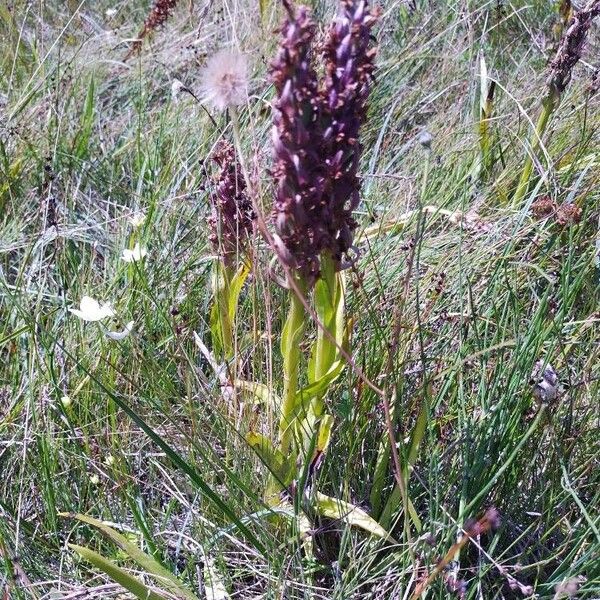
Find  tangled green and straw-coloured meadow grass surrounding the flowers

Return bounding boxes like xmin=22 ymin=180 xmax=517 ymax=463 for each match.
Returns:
xmin=0 ymin=0 xmax=600 ymax=600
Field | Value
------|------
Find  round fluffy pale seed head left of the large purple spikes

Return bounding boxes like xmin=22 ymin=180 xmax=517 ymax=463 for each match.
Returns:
xmin=201 ymin=50 xmax=248 ymax=110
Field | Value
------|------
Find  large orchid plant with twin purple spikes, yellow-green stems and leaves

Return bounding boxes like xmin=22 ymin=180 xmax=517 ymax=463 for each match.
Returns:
xmin=241 ymin=0 xmax=378 ymax=537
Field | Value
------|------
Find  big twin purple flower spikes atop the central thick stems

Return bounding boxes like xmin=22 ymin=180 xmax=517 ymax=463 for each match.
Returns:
xmin=271 ymin=0 xmax=377 ymax=283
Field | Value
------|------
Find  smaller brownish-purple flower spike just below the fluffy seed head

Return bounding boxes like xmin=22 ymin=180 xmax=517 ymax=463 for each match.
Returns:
xmin=209 ymin=141 xmax=254 ymax=266
